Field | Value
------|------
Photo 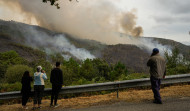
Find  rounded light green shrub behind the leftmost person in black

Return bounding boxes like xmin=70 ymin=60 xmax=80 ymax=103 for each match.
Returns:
xmin=5 ymin=65 xmax=33 ymax=83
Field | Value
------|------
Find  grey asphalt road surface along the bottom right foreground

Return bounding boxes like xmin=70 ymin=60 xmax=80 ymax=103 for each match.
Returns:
xmin=51 ymin=97 xmax=190 ymax=111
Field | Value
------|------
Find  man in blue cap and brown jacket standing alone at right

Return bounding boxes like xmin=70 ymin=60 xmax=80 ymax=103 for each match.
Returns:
xmin=147 ymin=48 xmax=166 ymax=104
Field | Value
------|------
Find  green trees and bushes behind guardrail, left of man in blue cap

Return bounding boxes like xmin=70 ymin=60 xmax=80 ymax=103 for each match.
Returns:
xmin=0 ymin=51 xmax=129 ymax=92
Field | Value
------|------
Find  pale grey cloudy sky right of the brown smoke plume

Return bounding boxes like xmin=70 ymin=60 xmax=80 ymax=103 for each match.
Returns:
xmin=122 ymin=0 xmax=190 ymax=42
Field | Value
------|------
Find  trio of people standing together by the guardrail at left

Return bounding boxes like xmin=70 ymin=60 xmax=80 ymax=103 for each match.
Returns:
xmin=21 ymin=62 xmax=63 ymax=110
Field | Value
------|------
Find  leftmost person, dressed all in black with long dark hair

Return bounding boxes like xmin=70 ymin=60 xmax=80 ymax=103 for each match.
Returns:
xmin=21 ymin=71 xmax=33 ymax=109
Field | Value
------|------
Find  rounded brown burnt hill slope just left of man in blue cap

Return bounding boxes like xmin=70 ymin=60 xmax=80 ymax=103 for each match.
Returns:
xmin=102 ymin=44 xmax=149 ymax=72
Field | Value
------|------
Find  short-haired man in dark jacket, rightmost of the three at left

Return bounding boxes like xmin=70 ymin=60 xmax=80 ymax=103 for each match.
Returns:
xmin=50 ymin=62 xmax=63 ymax=107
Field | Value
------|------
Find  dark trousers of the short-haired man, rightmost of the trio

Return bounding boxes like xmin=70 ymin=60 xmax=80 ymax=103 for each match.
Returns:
xmin=51 ymin=84 xmax=62 ymax=105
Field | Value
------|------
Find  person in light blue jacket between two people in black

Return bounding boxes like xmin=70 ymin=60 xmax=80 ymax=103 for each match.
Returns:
xmin=33 ymin=66 xmax=47 ymax=110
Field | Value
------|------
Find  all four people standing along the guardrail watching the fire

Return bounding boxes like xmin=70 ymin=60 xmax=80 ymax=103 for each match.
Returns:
xmin=21 ymin=48 xmax=166 ymax=109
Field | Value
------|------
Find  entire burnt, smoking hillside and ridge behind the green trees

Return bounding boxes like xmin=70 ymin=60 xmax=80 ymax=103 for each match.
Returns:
xmin=0 ymin=20 xmax=190 ymax=72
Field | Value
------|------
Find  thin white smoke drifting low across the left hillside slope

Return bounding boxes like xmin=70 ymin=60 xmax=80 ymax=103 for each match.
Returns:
xmin=13 ymin=26 xmax=95 ymax=60
